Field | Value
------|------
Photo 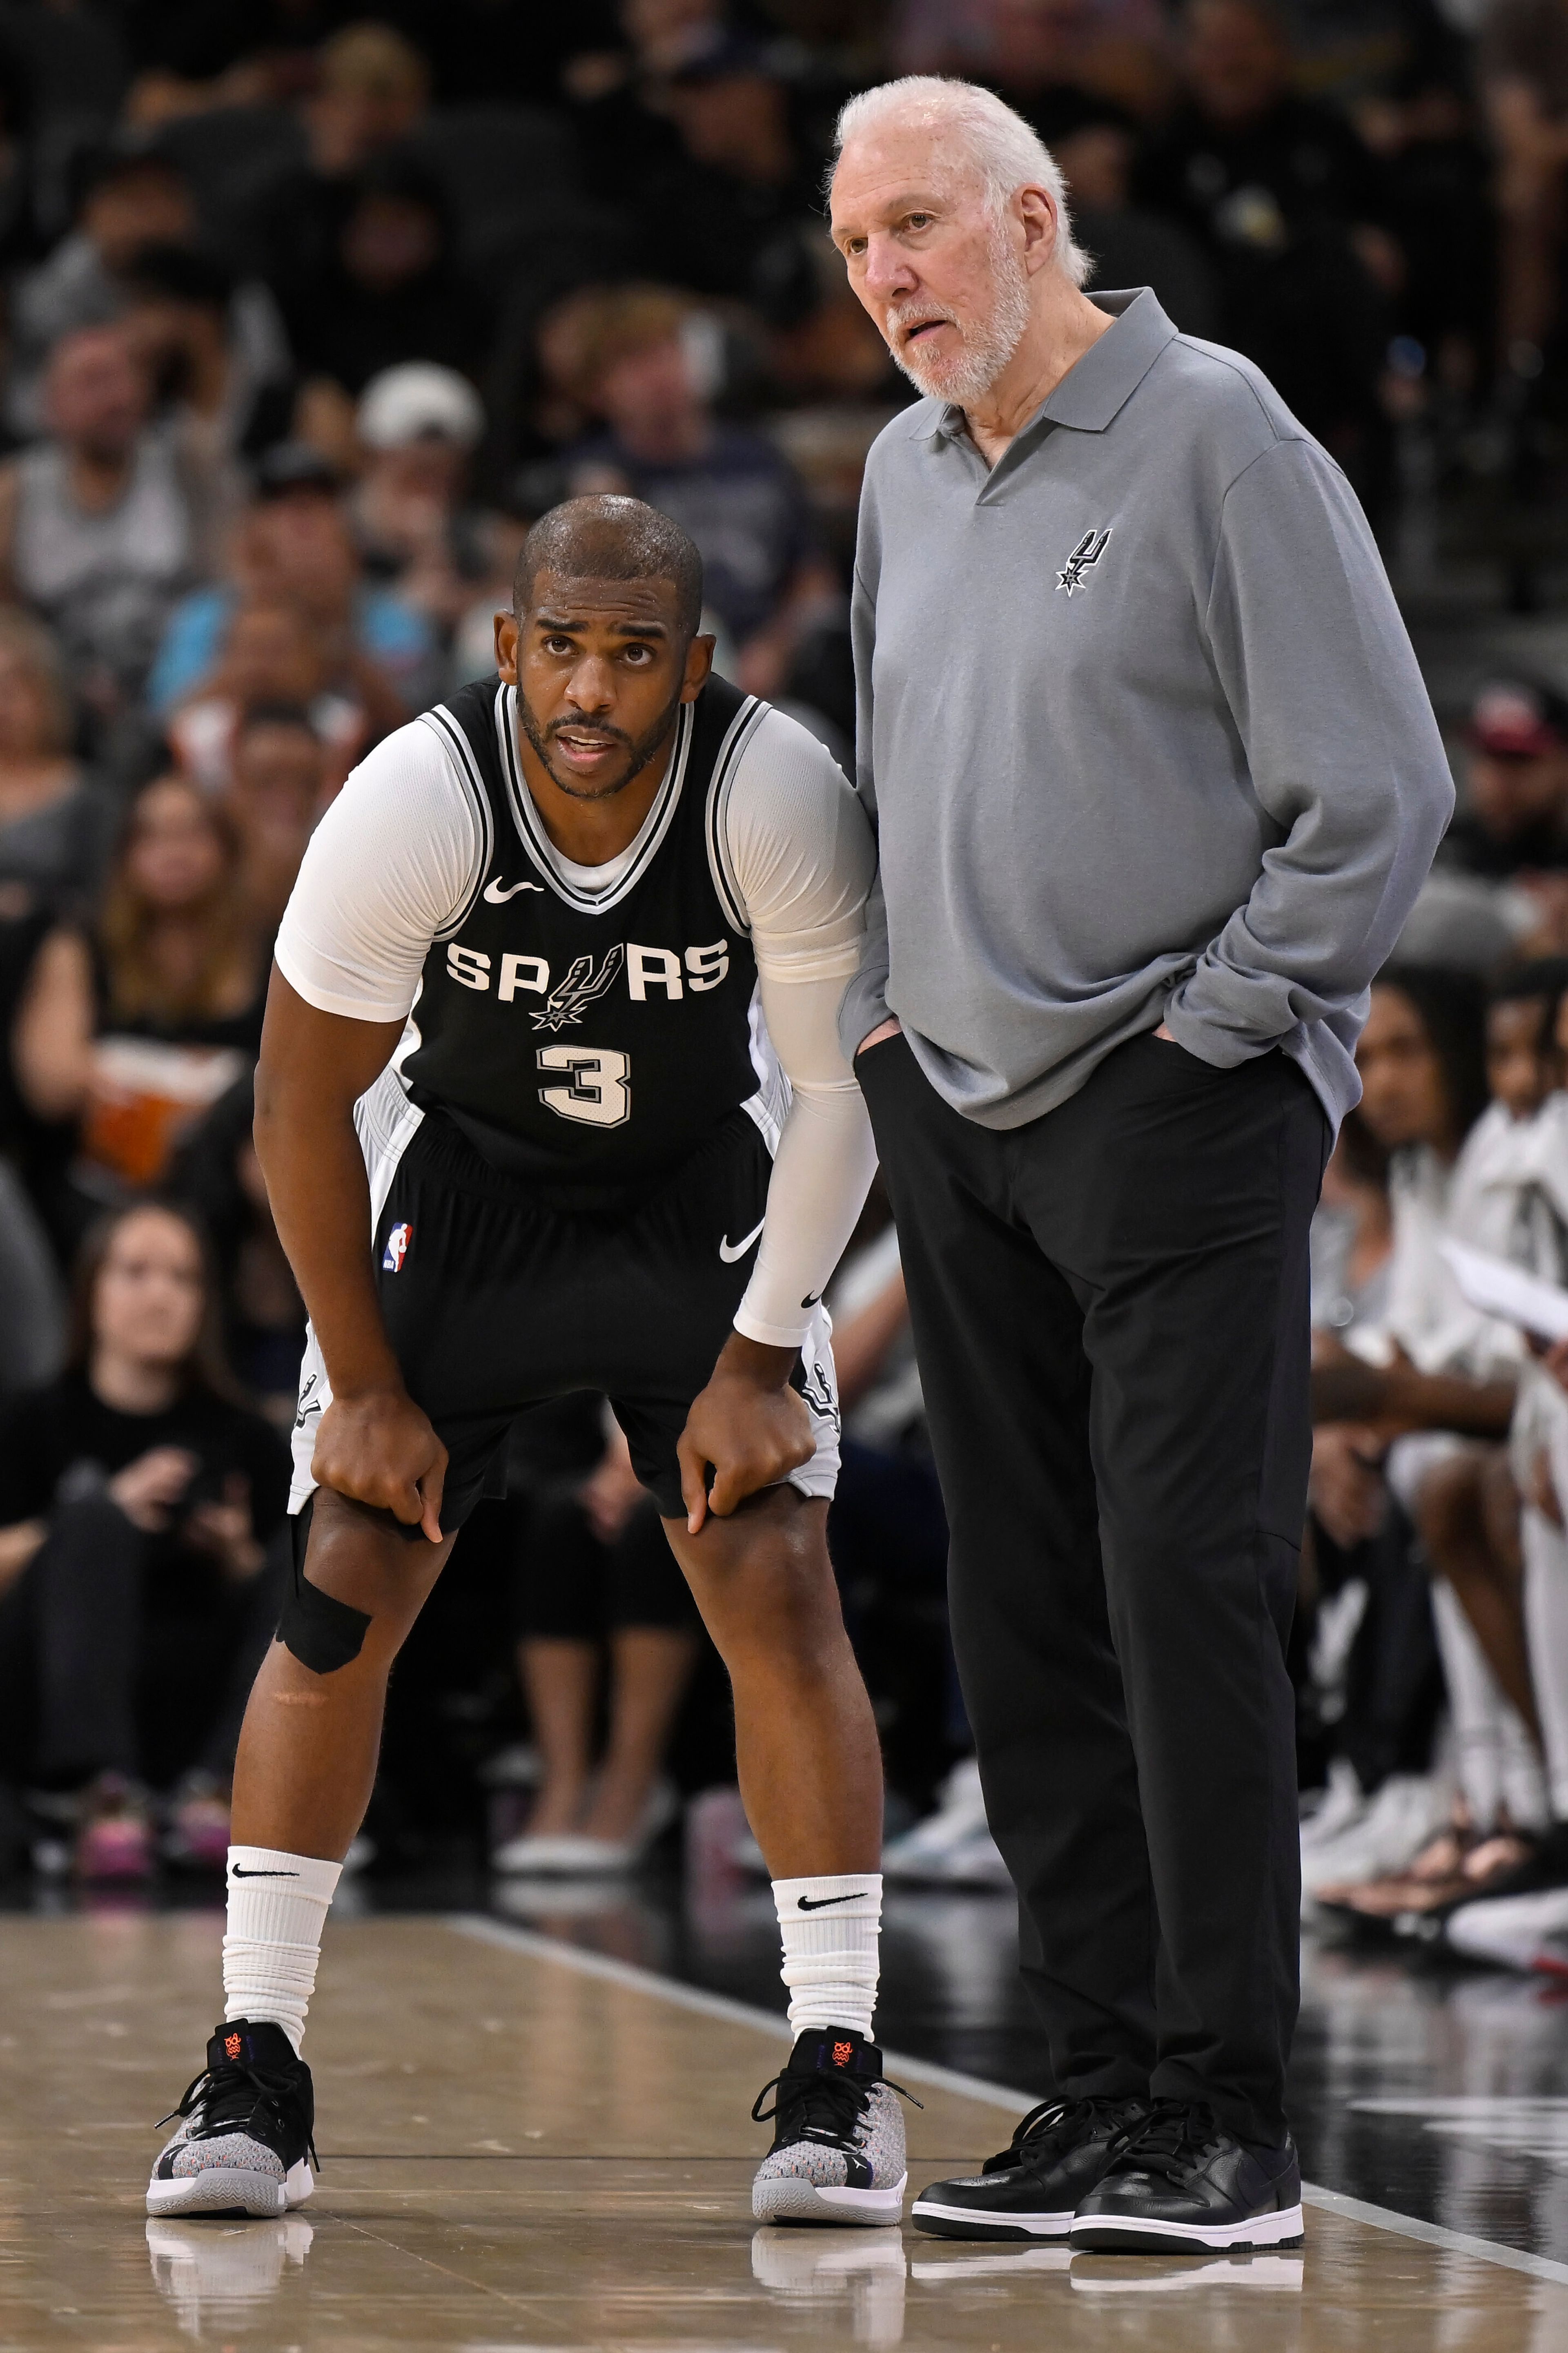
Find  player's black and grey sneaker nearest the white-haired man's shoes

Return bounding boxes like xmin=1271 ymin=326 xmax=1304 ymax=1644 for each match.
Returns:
xmin=752 ymin=2026 xmax=919 ymax=2224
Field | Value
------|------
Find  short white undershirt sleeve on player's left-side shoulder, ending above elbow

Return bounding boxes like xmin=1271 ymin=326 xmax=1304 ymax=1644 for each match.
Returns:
xmin=273 ymin=720 xmax=484 ymax=1021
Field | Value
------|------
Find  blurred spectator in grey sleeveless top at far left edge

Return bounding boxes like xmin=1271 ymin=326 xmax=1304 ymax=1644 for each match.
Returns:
xmin=0 ymin=327 xmax=221 ymax=715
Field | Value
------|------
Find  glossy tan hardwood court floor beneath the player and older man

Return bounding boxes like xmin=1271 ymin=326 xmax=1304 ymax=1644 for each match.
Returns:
xmin=0 ymin=1911 xmax=1568 ymax=2353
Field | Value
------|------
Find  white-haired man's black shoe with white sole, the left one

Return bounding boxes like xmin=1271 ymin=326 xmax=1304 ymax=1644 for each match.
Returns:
xmin=910 ymin=2099 xmax=1145 ymax=2238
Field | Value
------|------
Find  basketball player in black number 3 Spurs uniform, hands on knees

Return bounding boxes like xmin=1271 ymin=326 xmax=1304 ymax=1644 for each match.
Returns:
xmin=148 ymin=497 xmax=905 ymax=2224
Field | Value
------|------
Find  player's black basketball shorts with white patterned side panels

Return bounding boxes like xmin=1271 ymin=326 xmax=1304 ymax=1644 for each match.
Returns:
xmin=289 ymin=1087 xmax=839 ymax=1530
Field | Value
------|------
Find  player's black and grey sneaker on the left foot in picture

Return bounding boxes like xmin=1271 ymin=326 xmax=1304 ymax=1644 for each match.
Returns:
xmin=148 ymin=2019 xmax=320 ymax=2219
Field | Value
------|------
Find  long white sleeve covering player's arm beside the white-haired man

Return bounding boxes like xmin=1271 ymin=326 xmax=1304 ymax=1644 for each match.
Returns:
xmin=724 ymin=711 xmax=877 ymax=1348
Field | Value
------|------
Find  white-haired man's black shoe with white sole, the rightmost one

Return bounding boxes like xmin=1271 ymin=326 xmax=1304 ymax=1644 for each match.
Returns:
xmin=1072 ymin=2099 xmax=1302 ymax=2254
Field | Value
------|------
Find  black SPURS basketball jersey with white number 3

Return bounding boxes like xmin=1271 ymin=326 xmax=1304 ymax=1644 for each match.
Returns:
xmin=400 ymin=678 xmax=783 ymax=1209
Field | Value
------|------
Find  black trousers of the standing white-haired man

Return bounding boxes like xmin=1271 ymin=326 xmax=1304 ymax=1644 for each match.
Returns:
xmin=856 ymin=1035 xmax=1328 ymax=2146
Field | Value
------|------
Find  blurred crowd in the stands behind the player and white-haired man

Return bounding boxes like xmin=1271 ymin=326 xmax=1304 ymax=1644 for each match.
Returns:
xmin=0 ymin=0 xmax=1568 ymax=1925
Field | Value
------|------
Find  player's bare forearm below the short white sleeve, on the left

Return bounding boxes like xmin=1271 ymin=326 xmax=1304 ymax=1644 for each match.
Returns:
xmin=256 ymin=1078 xmax=402 ymax=1400
